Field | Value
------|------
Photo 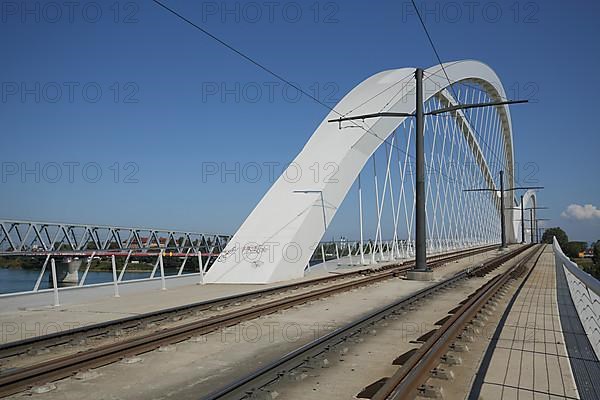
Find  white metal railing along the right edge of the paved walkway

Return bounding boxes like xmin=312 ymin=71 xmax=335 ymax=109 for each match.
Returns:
xmin=552 ymin=238 xmax=600 ymax=359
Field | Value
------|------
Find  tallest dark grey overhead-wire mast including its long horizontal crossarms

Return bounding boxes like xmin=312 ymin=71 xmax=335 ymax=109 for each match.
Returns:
xmin=327 ymin=68 xmax=528 ymax=272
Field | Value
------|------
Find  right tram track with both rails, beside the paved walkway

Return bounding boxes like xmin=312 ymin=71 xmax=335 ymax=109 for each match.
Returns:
xmin=203 ymin=246 xmax=533 ymax=400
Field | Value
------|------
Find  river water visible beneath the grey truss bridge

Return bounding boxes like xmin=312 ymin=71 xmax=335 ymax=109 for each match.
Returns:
xmin=0 ymin=268 xmax=152 ymax=294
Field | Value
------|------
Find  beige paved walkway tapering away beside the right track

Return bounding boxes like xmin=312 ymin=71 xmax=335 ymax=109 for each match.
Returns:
xmin=471 ymin=246 xmax=580 ymax=400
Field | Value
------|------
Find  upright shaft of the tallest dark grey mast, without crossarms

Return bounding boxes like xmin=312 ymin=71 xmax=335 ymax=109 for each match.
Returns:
xmin=415 ymin=68 xmax=428 ymax=271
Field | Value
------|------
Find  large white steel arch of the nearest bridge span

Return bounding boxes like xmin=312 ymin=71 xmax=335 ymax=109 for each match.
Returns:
xmin=206 ymin=60 xmax=514 ymax=283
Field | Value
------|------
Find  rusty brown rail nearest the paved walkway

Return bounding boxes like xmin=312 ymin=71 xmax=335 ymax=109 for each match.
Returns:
xmin=372 ymin=247 xmax=544 ymax=400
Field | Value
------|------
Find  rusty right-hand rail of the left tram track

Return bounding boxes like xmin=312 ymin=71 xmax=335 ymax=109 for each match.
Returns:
xmin=0 ymin=245 xmax=496 ymax=397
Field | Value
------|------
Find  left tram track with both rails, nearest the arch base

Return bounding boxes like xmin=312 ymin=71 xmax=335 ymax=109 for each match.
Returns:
xmin=0 ymin=246 xmax=496 ymax=397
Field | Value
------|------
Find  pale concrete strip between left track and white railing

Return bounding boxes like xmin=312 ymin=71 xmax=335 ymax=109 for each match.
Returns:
xmin=0 ymin=261 xmax=368 ymax=344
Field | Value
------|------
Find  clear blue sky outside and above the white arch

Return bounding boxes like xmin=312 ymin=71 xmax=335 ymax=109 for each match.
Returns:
xmin=0 ymin=0 xmax=600 ymax=241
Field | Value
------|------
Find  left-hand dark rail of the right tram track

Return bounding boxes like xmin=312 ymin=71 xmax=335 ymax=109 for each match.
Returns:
xmin=202 ymin=246 xmax=530 ymax=400
